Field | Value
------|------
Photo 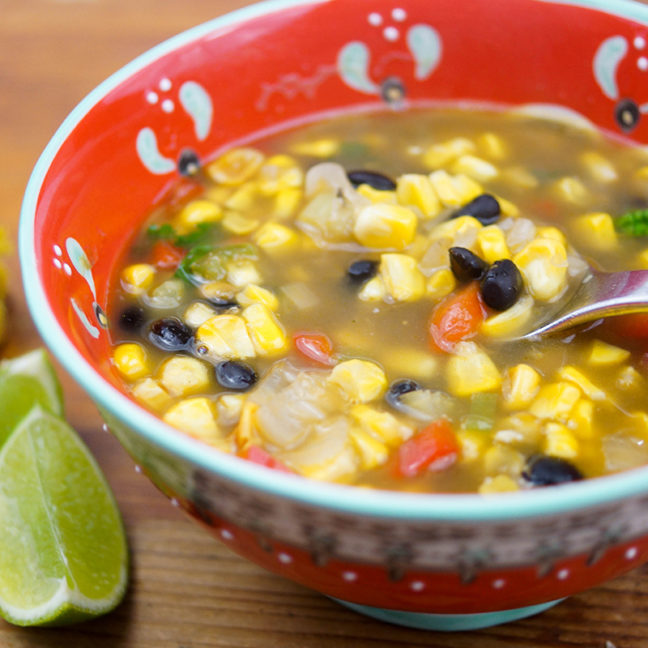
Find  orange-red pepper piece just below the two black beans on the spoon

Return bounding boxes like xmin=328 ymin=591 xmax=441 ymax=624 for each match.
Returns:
xmin=428 ymin=282 xmax=488 ymax=352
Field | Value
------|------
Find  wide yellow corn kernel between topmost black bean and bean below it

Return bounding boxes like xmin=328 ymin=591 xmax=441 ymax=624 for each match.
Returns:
xmin=353 ymin=204 xmax=418 ymax=250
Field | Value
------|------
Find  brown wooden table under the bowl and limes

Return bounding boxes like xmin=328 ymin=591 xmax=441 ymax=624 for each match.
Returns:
xmin=0 ymin=0 xmax=648 ymax=648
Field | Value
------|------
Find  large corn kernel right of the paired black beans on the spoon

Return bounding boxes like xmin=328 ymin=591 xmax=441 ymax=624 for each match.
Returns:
xmin=513 ymin=238 xmax=567 ymax=301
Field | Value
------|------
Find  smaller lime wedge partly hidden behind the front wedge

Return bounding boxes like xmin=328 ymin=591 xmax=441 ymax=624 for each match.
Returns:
xmin=0 ymin=349 xmax=63 ymax=447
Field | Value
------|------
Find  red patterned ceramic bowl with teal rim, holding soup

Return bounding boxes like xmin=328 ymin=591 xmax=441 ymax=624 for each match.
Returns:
xmin=20 ymin=0 xmax=648 ymax=630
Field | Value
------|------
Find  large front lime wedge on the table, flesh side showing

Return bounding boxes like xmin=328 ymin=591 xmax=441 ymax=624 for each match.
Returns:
xmin=0 ymin=405 xmax=128 ymax=625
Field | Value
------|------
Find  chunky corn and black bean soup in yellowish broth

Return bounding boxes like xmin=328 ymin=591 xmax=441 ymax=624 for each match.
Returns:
xmin=109 ymin=109 xmax=648 ymax=494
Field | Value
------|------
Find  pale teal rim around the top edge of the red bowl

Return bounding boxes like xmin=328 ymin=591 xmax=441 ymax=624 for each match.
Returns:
xmin=18 ymin=0 xmax=648 ymax=522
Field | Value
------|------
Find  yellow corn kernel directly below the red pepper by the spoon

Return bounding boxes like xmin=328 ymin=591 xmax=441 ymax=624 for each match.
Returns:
xmin=446 ymin=342 xmax=502 ymax=396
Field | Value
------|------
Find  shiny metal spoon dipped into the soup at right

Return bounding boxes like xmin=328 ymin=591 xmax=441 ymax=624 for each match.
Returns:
xmin=515 ymin=270 xmax=648 ymax=340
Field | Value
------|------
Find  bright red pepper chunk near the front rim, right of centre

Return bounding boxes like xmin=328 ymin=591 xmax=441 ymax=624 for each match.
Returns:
xmin=396 ymin=419 xmax=459 ymax=477
